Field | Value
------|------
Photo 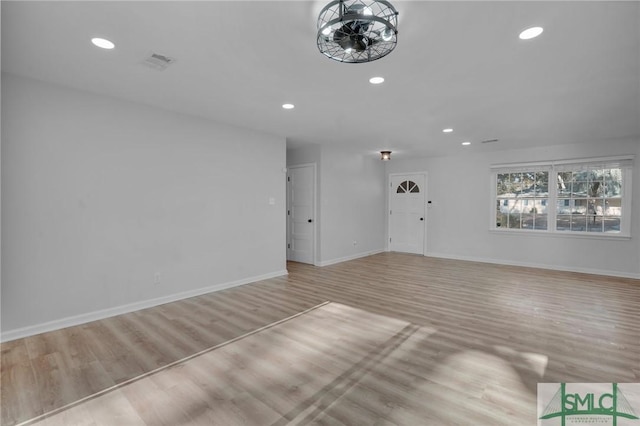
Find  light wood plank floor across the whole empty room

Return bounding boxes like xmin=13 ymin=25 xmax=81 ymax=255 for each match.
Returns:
xmin=0 ymin=253 xmax=640 ymax=426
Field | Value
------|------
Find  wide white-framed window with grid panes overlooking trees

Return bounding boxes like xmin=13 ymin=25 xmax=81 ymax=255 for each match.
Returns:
xmin=491 ymin=156 xmax=633 ymax=236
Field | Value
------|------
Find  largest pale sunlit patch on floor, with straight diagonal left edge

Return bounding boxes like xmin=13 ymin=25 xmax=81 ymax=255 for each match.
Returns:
xmin=23 ymin=303 xmax=435 ymax=426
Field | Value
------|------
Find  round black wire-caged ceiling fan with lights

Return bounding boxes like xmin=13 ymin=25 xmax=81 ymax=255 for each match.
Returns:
xmin=317 ymin=0 xmax=398 ymax=63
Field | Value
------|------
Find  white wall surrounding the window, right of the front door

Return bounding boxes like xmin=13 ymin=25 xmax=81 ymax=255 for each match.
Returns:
xmin=387 ymin=141 xmax=640 ymax=278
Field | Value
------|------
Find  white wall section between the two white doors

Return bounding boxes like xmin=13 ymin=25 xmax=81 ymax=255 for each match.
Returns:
xmin=287 ymin=145 xmax=386 ymax=266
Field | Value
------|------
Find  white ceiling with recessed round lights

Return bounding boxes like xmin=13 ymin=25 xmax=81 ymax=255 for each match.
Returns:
xmin=2 ymin=0 xmax=640 ymax=158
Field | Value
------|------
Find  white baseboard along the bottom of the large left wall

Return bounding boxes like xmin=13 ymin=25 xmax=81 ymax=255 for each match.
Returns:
xmin=0 ymin=270 xmax=288 ymax=342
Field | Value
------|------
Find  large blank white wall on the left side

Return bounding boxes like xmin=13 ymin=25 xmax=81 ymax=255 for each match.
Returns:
xmin=2 ymin=74 xmax=286 ymax=340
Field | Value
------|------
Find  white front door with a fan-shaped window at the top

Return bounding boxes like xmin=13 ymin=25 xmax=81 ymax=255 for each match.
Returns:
xmin=389 ymin=174 xmax=426 ymax=254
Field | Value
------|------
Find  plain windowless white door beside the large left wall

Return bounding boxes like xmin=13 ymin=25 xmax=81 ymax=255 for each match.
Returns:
xmin=287 ymin=165 xmax=315 ymax=264
